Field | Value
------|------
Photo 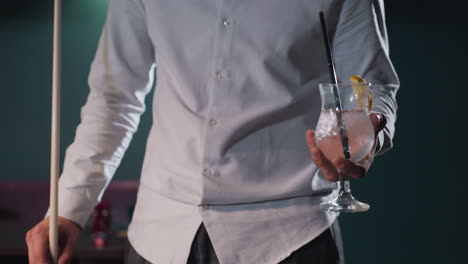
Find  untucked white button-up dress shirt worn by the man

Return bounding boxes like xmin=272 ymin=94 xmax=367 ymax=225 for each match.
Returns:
xmin=54 ymin=0 xmax=399 ymax=264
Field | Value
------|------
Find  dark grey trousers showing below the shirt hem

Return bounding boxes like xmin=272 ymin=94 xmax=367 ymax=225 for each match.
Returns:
xmin=125 ymin=221 xmax=344 ymax=264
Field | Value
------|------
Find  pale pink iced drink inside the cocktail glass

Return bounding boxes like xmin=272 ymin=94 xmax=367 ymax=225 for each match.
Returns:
xmin=315 ymin=110 xmax=374 ymax=162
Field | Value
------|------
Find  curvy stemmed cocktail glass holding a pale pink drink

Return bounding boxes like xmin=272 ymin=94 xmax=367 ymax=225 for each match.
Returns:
xmin=315 ymin=83 xmax=375 ymax=212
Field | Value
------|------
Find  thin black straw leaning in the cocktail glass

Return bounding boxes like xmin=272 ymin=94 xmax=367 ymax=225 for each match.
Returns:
xmin=319 ymin=11 xmax=351 ymax=159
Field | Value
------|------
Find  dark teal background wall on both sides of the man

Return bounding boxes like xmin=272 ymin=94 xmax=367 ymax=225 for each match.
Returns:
xmin=0 ymin=0 xmax=468 ymax=264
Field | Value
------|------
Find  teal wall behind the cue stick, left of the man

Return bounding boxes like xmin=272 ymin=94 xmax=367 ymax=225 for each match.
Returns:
xmin=0 ymin=0 xmax=151 ymax=180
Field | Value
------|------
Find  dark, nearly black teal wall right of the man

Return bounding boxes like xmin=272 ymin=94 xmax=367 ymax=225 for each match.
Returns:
xmin=340 ymin=11 xmax=468 ymax=264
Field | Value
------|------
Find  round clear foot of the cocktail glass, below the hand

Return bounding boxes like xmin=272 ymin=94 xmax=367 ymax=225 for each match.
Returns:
xmin=320 ymin=194 xmax=370 ymax=213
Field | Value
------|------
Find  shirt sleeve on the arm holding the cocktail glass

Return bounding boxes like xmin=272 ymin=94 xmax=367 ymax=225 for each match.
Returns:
xmin=333 ymin=0 xmax=400 ymax=154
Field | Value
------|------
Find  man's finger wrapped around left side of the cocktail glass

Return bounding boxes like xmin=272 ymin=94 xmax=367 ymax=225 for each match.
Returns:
xmin=306 ymin=130 xmax=339 ymax=182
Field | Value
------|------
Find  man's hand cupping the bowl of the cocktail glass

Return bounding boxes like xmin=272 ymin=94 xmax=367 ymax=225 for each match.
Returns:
xmin=306 ymin=113 xmax=387 ymax=181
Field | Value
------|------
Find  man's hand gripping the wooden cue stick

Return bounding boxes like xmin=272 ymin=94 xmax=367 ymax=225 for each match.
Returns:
xmin=26 ymin=217 xmax=81 ymax=264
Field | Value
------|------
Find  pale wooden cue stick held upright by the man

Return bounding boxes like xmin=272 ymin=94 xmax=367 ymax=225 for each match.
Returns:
xmin=49 ymin=0 xmax=62 ymax=263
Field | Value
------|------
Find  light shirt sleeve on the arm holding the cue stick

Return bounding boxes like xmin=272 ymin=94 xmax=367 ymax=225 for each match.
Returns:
xmin=49 ymin=0 xmax=155 ymax=227
